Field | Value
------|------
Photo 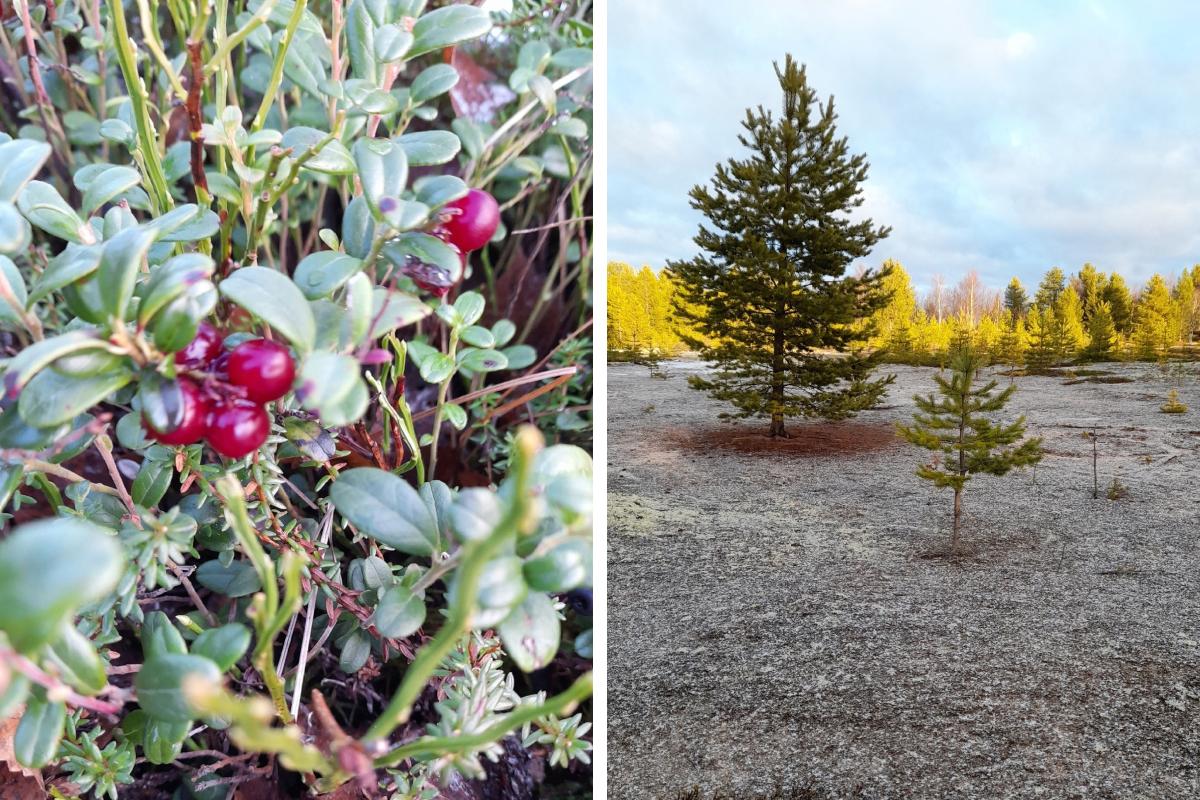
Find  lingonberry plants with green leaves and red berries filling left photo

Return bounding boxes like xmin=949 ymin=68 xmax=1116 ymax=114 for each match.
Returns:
xmin=0 ymin=0 xmax=592 ymax=800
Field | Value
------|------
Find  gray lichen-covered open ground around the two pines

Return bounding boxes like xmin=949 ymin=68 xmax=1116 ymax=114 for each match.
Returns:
xmin=608 ymin=361 xmax=1200 ymax=800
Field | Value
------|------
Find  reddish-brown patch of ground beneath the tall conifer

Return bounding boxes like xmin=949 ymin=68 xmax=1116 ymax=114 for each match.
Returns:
xmin=664 ymin=422 xmax=899 ymax=458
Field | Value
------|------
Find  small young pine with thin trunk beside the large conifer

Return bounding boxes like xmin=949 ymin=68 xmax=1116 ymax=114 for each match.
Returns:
xmin=896 ymin=349 xmax=1042 ymax=553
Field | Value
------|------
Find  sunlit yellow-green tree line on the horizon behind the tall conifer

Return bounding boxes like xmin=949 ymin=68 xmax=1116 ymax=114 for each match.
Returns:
xmin=607 ymin=260 xmax=1200 ymax=371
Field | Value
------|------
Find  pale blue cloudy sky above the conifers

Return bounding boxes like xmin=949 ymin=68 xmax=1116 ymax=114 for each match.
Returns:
xmin=608 ymin=0 xmax=1200 ymax=288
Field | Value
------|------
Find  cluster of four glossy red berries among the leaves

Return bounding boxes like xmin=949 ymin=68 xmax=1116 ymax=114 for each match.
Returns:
xmin=142 ymin=323 xmax=295 ymax=458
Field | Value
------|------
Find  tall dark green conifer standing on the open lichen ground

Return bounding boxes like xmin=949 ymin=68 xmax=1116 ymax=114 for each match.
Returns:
xmin=671 ymin=56 xmax=893 ymax=435
